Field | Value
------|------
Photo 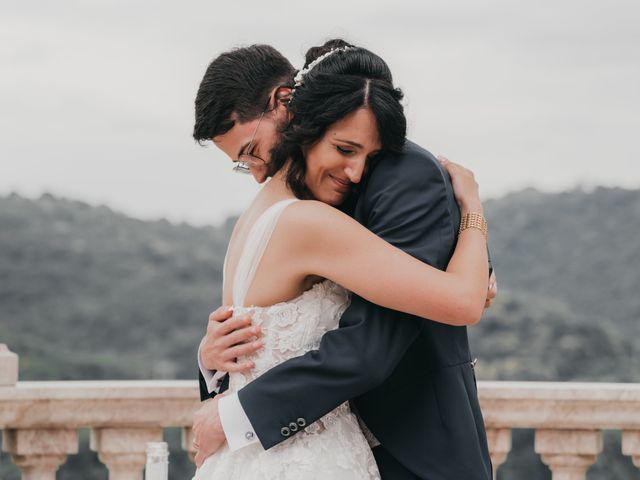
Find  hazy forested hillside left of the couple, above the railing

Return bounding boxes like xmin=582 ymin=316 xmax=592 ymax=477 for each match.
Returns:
xmin=0 ymin=195 xmax=230 ymax=379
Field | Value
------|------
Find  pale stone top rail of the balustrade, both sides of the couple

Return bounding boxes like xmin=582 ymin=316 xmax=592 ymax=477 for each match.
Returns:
xmin=0 ymin=380 xmax=640 ymax=430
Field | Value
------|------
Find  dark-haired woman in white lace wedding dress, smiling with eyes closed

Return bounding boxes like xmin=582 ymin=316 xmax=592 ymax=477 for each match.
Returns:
xmin=194 ymin=42 xmax=488 ymax=480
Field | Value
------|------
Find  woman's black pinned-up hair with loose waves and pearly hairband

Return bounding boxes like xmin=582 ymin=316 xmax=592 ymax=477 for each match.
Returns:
xmin=270 ymin=39 xmax=407 ymax=199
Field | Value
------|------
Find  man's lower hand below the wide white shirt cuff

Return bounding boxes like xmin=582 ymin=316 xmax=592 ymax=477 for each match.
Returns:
xmin=192 ymin=393 xmax=227 ymax=468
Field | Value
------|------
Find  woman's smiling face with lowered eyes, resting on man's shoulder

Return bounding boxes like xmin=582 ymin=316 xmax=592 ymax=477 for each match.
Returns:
xmin=305 ymin=108 xmax=381 ymax=205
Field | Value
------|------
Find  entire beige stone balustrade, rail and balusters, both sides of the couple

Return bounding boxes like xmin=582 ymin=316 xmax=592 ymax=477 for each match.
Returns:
xmin=0 ymin=345 xmax=640 ymax=480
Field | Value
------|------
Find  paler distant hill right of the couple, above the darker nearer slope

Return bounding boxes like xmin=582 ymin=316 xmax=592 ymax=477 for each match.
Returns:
xmin=486 ymin=188 xmax=640 ymax=335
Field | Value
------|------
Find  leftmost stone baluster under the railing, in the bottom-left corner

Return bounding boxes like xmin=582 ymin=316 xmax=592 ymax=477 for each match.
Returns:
xmin=2 ymin=429 xmax=78 ymax=480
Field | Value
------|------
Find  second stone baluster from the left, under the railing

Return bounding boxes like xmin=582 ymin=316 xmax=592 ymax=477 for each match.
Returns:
xmin=90 ymin=427 xmax=162 ymax=480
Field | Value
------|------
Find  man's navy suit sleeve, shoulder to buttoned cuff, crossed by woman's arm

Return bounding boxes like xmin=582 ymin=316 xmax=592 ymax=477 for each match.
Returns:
xmin=238 ymin=148 xmax=459 ymax=448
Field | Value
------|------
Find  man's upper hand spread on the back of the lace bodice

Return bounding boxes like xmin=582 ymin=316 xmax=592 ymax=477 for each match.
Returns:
xmin=200 ymin=307 xmax=263 ymax=372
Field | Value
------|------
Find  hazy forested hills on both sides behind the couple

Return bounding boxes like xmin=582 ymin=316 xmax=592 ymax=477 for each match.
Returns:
xmin=0 ymin=188 xmax=640 ymax=381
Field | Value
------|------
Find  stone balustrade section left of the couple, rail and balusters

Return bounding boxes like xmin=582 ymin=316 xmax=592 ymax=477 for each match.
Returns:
xmin=0 ymin=380 xmax=200 ymax=480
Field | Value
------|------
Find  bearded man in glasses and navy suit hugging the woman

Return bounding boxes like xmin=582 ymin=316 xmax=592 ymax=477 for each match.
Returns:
xmin=194 ymin=45 xmax=492 ymax=480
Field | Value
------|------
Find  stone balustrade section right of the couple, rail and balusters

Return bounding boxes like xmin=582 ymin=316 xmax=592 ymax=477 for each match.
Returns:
xmin=478 ymin=382 xmax=640 ymax=480
